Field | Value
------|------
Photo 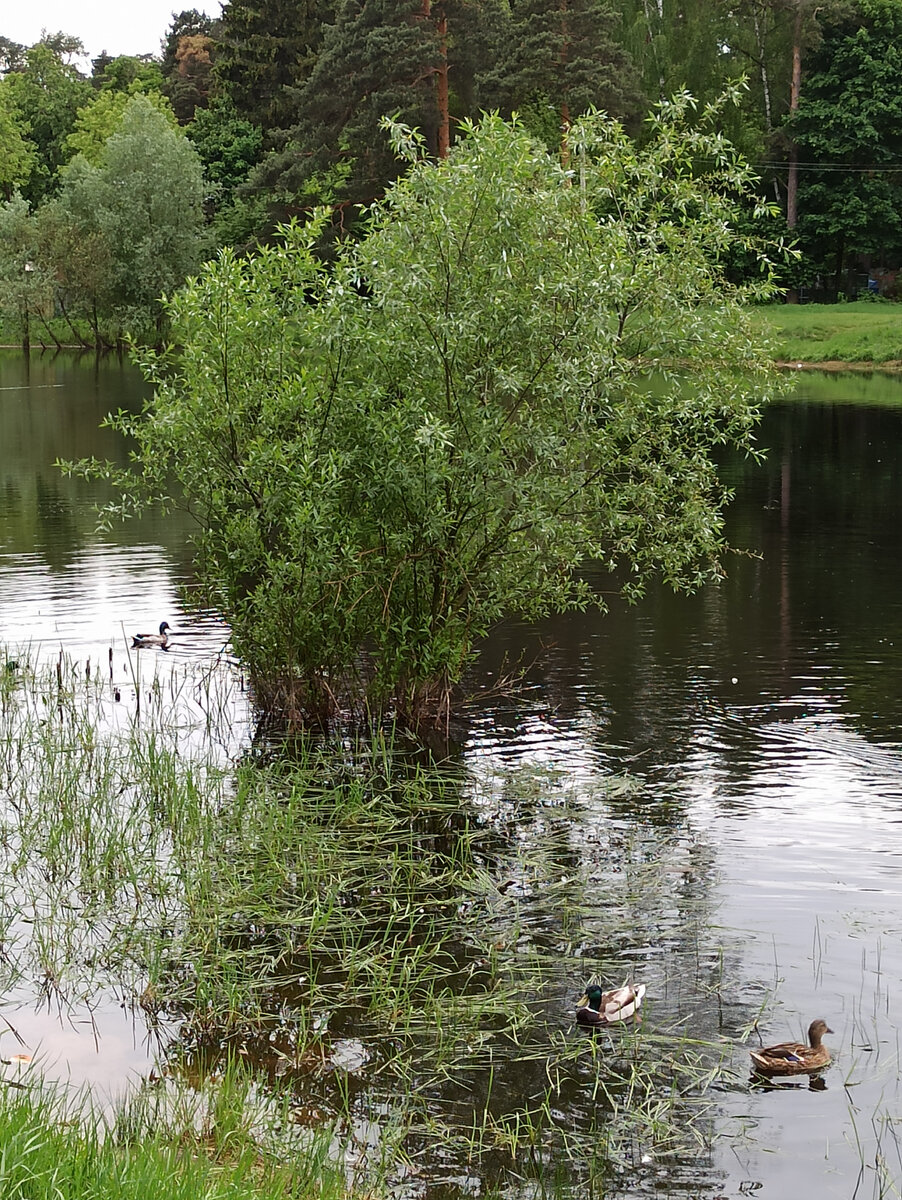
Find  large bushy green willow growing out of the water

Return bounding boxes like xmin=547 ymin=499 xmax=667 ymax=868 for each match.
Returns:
xmin=72 ymin=105 xmax=786 ymax=727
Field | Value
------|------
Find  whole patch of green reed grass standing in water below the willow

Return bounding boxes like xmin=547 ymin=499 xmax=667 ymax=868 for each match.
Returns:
xmin=0 ymin=660 xmax=743 ymax=1195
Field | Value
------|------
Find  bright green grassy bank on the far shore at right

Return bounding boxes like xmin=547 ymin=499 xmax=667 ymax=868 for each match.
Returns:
xmin=753 ymin=301 xmax=902 ymax=364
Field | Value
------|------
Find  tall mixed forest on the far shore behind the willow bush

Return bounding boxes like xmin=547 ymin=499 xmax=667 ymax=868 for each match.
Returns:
xmin=0 ymin=0 xmax=902 ymax=346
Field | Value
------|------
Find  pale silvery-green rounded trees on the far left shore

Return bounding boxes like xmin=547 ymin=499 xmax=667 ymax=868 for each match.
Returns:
xmin=0 ymin=92 xmax=205 ymax=344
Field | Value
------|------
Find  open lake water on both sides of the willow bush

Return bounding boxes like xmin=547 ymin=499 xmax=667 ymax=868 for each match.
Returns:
xmin=0 ymin=355 xmax=902 ymax=1200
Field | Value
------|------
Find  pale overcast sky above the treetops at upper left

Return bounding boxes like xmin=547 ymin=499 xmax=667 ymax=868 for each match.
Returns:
xmin=0 ymin=0 xmax=222 ymax=58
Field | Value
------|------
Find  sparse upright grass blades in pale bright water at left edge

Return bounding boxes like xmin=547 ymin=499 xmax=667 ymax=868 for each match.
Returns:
xmin=0 ymin=660 xmax=239 ymax=1000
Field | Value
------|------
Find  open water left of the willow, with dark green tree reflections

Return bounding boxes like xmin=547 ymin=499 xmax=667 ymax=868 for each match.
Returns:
xmin=0 ymin=352 xmax=206 ymax=664
